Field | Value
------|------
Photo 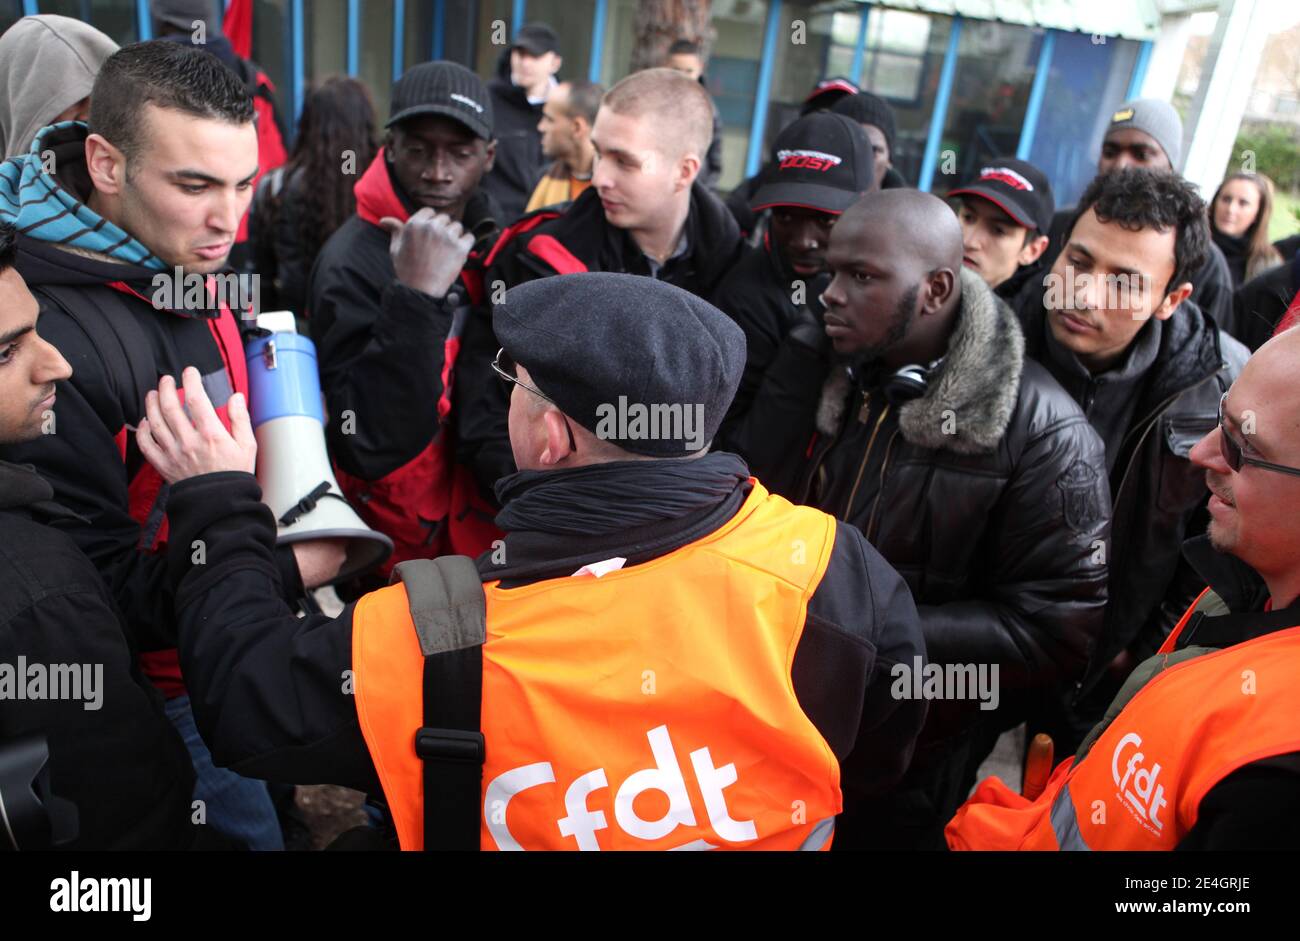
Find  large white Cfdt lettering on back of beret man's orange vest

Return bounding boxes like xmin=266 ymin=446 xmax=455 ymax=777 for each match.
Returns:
xmin=484 ymin=725 xmax=758 ymax=850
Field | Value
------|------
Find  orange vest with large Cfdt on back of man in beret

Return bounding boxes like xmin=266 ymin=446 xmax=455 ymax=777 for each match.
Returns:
xmin=352 ymin=481 xmax=842 ymax=850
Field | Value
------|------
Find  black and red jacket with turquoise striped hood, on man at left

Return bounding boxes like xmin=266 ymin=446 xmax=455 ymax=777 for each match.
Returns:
xmin=0 ymin=122 xmax=302 ymax=698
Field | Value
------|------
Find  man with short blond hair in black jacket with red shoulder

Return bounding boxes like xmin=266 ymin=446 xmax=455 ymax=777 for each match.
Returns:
xmin=452 ymin=69 xmax=741 ymax=495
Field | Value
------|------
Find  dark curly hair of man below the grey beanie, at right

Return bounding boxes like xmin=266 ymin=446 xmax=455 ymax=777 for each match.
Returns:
xmin=1066 ymin=168 xmax=1210 ymax=294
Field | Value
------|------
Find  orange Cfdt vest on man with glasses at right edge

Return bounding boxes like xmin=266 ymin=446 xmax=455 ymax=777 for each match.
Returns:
xmin=945 ymin=589 xmax=1300 ymax=850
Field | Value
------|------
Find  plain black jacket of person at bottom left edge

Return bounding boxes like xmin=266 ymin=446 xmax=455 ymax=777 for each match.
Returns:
xmin=0 ymin=460 xmax=194 ymax=850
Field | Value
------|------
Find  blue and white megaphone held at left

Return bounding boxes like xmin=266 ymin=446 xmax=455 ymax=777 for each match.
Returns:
xmin=244 ymin=311 xmax=393 ymax=584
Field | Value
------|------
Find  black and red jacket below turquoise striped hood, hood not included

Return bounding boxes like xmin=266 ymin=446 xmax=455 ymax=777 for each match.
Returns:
xmin=4 ymin=237 xmax=302 ymax=698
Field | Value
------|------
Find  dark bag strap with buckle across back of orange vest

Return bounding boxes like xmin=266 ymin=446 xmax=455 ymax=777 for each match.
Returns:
xmin=393 ymin=555 xmax=488 ymax=850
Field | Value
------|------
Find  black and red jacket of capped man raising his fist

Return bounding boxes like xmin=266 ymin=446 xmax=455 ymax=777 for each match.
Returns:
xmin=307 ymin=149 xmax=499 ymax=571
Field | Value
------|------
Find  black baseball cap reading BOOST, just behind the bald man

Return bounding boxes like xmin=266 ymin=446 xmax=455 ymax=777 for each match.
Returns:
xmin=749 ymin=110 xmax=875 ymax=214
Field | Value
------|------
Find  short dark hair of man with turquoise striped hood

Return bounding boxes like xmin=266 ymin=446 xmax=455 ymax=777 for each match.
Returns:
xmin=90 ymin=39 xmax=254 ymax=161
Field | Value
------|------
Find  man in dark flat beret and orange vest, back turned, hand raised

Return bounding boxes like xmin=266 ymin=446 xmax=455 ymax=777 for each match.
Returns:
xmin=131 ymin=274 xmax=926 ymax=850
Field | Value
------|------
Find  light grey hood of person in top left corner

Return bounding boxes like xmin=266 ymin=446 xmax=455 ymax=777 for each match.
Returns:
xmin=0 ymin=16 xmax=117 ymax=160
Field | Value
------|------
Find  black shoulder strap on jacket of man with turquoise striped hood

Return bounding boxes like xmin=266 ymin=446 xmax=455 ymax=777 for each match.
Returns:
xmin=33 ymin=285 xmax=159 ymax=422
